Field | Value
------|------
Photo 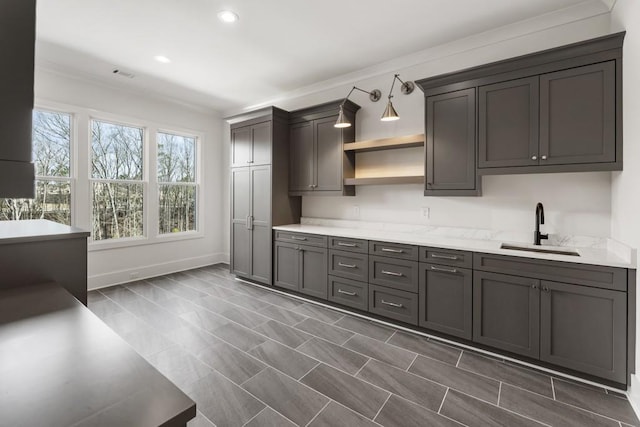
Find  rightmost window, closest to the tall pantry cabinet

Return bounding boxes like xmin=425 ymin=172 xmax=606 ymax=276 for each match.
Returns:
xmin=158 ymin=132 xmax=197 ymax=234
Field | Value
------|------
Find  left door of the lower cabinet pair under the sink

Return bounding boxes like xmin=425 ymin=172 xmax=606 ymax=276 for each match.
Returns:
xmin=473 ymin=272 xmax=540 ymax=358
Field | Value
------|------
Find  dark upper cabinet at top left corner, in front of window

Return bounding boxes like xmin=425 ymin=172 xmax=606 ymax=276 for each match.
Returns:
xmin=0 ymin=0 xmax=36 ymax=198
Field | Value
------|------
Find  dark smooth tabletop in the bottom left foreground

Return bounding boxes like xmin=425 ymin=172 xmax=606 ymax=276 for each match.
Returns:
xmin=0 ymin=284 xmax=196 ymax=427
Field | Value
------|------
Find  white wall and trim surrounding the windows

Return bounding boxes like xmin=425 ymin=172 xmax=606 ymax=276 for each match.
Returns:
xmin=35 ymin=69 xmax=228 ymax=289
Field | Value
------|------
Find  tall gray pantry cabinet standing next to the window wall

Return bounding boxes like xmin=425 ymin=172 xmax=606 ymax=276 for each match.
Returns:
xmin=228 ymin=107 xmax=301 ymax=285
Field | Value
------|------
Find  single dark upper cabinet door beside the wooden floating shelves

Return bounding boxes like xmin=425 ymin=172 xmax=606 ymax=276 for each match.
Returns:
xmin=425 ymin=88 xmax=476 ymax=195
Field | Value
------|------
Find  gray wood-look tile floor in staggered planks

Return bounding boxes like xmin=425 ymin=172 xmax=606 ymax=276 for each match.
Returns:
xmin=89 ymin=264 xmax=640 ymax=427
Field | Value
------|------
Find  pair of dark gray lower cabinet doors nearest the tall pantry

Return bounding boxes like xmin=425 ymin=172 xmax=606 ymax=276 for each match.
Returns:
xmin=274 ymin=241 xmax=327 ymax=299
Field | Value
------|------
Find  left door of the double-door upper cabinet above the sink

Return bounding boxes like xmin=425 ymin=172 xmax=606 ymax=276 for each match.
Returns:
xmin=478 ymin=76 xmax=539 ymax=169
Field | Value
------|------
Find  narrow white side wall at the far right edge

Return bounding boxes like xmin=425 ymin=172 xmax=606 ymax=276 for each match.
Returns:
xmin=611 ymin=0 xmax=640 ymax=402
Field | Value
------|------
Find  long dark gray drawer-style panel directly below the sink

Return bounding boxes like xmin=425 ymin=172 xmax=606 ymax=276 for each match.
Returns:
xmin=473 ymin=253 xmax=627 ymax=291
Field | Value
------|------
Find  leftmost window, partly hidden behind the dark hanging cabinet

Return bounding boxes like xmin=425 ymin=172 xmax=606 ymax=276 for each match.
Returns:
xmin=0 ymin=110 xmax=71 ymax=225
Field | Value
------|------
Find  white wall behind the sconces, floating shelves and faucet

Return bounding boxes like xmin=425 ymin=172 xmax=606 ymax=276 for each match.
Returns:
xmin=226 ymin=14 xmax=611 ymax=237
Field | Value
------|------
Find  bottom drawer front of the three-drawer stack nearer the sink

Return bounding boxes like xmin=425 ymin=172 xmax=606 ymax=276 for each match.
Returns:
xmin=369 ymin=284 xmax=418 ymax=325
